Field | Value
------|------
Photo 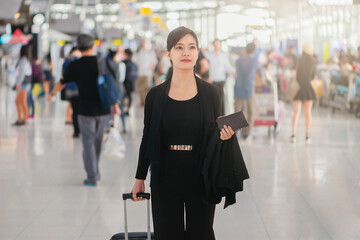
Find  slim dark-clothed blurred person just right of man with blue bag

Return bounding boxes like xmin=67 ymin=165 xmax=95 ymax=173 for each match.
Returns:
xmin=123 ymin=48 xmax=138 ymax=115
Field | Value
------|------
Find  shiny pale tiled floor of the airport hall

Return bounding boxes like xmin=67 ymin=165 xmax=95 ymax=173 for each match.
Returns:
xmin=0 ymin=83 xmax=360 ymax=240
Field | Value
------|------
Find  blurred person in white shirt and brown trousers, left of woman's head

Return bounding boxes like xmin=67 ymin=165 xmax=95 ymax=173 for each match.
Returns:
xmin=134 ymin=40 xmax=157 ymax=106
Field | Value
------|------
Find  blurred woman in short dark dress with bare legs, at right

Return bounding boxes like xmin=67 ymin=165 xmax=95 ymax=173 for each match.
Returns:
xmin=290 ymin=43 xmax=316 ymax=144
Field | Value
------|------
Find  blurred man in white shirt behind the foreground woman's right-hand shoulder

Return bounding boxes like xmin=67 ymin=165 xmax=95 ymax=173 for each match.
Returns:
xmin=204 ymin=39 xmax=235 ymax=114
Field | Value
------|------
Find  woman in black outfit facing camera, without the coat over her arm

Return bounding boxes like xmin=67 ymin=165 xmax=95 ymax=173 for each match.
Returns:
xmin=132 ymin=27 xmax=248 ymax=240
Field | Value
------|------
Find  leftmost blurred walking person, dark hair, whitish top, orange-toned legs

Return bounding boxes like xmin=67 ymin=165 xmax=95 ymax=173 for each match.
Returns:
xmin=12 ymin=45 xmax=32 ymax=126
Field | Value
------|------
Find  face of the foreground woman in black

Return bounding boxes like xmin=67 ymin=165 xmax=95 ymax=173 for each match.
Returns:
xmin=168 ymin=34 xmax=199 ymax=70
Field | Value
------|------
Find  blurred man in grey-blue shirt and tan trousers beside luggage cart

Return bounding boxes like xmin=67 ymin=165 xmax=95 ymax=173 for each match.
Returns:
xmin=234 ymin=43 xmax=264 ymax=139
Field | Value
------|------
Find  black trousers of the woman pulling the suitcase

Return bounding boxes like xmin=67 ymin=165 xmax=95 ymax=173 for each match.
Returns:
xmin=151 ymin=150 xmax=215 ymax=240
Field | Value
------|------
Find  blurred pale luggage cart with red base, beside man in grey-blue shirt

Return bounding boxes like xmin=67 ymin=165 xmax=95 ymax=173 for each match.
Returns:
xmin=253 ymin=81 xmax=280 ymax=137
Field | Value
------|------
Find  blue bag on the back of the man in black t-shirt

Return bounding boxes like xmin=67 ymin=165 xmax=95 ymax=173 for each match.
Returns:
xmin=96 ymin=58 xmax=121 ymax=110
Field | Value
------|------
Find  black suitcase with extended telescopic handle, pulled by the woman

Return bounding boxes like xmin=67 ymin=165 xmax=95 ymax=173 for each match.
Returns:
xmin=110 ymin=193 xmax=155 ymax=240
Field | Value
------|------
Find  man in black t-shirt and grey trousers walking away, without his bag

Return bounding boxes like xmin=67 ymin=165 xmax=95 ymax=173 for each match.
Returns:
xmin=48 ymin=34 xmax=120 ymax=186
